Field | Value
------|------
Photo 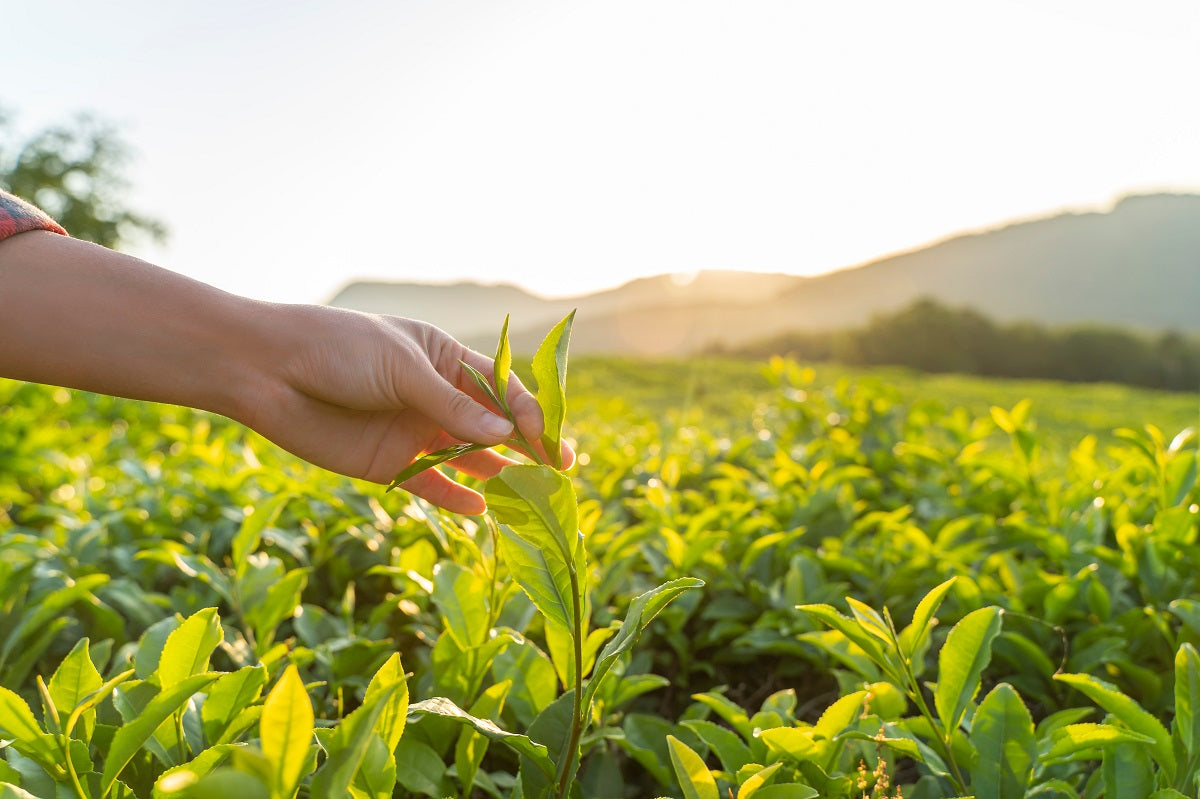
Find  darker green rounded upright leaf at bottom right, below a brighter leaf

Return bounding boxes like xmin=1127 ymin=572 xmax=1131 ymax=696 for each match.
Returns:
xmin=971 ymin=683 xmax=1037 ymax=799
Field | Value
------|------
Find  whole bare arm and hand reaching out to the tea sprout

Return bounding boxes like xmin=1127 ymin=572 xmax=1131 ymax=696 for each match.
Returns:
xmin=0 ymin=230 xmax=574 ymax=513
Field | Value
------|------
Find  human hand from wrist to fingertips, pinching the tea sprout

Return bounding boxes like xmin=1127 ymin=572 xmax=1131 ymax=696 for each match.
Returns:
xmin=238 ymin=306 xmax=575 ymax=515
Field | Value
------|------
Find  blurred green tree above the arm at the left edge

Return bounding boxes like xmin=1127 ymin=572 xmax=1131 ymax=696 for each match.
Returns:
xmin=0 ymin=109 xmax=166 ymax=247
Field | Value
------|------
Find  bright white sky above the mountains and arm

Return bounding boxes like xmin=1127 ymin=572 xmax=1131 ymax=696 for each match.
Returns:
xmin=0 ymin=0 xmax=1200 ymax=301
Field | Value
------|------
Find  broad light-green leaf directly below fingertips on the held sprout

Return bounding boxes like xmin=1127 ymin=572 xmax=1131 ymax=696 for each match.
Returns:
xmin=484 ymin=465 xmax=587 ymax=636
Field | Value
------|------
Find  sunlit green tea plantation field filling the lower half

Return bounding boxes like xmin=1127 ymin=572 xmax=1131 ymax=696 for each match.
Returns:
xmin=0 ymin=359 xmax=1200 ymax=799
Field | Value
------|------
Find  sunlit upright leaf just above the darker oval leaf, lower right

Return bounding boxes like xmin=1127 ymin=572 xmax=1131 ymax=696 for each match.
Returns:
xmin=934 ymin=607 xmax=1001 ymax=734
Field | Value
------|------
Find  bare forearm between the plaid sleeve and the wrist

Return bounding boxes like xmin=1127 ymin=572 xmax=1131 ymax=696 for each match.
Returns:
xmin=0 ymin=232 xmax=275 ymax=417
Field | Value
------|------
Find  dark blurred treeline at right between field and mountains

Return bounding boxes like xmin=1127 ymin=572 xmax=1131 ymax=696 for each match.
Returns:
xmin=738 ymin=300 xmax=1200 ymax=391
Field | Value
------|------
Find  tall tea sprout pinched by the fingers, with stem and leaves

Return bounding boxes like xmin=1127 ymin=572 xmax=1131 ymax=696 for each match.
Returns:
xmin=391 ymin=311 xmax=703 ymax=799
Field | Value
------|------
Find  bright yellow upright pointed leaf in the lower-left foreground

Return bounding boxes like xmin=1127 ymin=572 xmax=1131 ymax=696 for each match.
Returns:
xmin=258 ymin=665 xmax=313 ymax=799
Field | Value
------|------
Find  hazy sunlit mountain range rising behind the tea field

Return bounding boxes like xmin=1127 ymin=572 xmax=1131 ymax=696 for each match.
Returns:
xmin=331 ymin=194 xmax=1200 ymax=355
